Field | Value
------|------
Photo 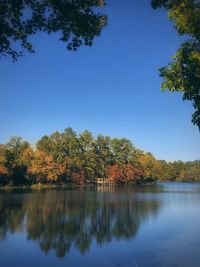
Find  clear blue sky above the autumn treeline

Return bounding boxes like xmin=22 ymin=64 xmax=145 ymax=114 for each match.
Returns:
xmin=0 ymin=0 xmax=200 ymax=161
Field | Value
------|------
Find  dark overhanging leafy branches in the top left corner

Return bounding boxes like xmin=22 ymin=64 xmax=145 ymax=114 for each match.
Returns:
xmin=0 ymin=0 xmax=107 ymax=61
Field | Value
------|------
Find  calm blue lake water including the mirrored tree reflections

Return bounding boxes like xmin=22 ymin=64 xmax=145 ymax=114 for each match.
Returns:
xmin=0 ymin=183 xmax=200 ymax=267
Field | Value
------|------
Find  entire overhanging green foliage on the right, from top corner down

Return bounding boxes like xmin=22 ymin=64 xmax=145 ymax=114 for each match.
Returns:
xmin=151 ymin=0 xmax=200 ymax=129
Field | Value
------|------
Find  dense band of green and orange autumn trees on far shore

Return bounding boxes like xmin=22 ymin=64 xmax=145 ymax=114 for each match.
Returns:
xmin=0 ymin=128 xmax=200 ymax=185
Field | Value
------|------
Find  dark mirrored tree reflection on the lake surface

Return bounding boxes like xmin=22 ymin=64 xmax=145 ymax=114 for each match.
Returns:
xmin=0 ymin=187 xmax=160 ymax=257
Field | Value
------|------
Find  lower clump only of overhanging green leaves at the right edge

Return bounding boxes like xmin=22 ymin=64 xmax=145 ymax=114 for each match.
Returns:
xmin=160 ymin=40 xmax=200 ymax=129
